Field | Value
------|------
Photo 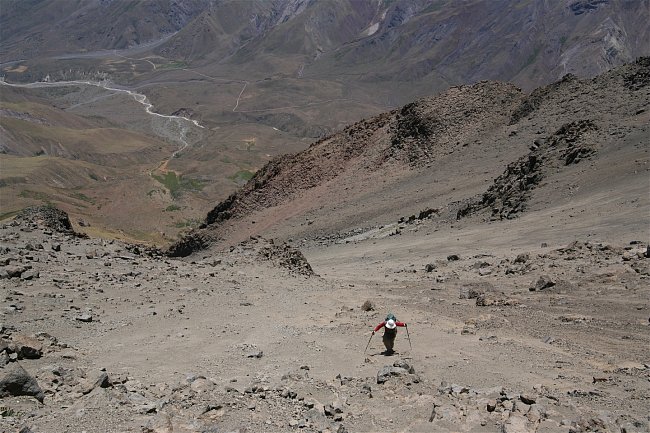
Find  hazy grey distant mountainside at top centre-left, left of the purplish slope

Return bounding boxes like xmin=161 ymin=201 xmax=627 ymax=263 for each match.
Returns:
xmin=156 ymin=0 xmax=381 ymax=64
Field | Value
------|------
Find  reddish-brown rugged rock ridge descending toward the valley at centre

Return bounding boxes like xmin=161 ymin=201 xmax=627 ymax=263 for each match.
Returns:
xmin=169 ymin=82 xmax=522 ymax=255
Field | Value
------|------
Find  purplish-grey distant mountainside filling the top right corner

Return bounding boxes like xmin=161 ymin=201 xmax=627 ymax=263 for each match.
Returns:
xmin=307 ymin=1 xmax=650 ymax=89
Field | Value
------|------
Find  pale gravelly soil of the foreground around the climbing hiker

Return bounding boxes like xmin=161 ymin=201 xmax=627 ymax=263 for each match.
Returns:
xmin=0 ymin=204 xmax=650 ymax=433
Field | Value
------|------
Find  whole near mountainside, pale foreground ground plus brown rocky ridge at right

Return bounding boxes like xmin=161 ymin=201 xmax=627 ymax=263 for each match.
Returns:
xmin=0 ymin=59 xmax=650 ymax=433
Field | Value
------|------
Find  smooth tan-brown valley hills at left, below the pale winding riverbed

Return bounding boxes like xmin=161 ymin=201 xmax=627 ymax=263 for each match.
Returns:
xmin=0 ymin=86 xmax=210 ymax=242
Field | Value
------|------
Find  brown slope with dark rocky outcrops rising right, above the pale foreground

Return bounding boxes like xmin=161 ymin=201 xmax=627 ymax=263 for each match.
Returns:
xmin=171 ymin=58 xmax=650 ymax=255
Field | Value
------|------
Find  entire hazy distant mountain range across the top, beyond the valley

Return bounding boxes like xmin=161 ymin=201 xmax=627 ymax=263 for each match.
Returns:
xmin=0 ymin=0 xmax=650 ymax=90
